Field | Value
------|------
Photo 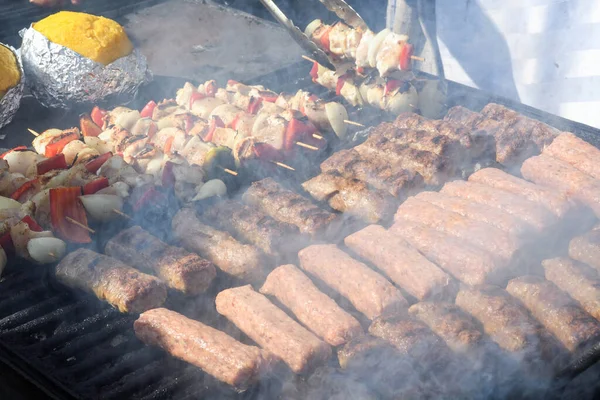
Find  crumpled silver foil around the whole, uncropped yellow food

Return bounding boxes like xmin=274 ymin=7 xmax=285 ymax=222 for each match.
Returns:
xmin=20 ymin=27 xmax=152 ymax=108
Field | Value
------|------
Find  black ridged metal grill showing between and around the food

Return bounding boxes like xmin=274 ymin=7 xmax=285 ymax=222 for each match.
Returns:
xmin=0 ymin=60 xmax=600 ymax=399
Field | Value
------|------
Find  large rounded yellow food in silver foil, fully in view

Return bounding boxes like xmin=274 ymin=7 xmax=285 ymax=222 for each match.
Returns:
xmin=21 ymin=11 xmax=152 ymax=108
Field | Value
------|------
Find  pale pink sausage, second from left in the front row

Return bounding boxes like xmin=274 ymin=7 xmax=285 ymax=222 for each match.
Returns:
xmin=216 ymin=285 xmax=331 ymax=374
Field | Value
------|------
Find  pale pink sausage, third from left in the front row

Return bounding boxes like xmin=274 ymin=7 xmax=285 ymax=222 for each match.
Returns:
xmin=260 ymin=265 xmax=363 ymax=346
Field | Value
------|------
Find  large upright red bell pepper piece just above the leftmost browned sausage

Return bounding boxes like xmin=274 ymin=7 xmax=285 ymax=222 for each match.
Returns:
xmin=50 ymin=187 xmax=92 ymax=243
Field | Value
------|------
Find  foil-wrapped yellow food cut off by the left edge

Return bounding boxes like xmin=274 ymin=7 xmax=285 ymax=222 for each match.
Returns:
xmin=0 ymin=43 xmax=25 ymax=128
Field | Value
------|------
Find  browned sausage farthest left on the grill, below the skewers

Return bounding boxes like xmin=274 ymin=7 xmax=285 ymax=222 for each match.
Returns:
xmin=56 ymin=249 xmax=167 ymax=313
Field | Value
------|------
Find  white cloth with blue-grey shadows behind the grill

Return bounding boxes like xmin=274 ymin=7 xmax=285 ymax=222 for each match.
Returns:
xmin=388 ymin=0 xmax=600 ymax=128
